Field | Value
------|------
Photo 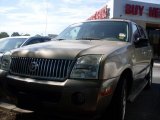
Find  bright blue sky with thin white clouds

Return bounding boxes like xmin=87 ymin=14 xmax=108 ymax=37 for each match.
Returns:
xmin=0 ymin=0 xmax=160 ymax=35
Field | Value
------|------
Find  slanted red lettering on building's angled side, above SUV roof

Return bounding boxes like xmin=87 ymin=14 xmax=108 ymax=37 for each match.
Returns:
xmin=88 ymin=6 xmax=109 ymax=20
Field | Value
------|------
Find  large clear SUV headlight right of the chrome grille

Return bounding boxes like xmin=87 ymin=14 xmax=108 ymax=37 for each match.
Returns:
xmin=70 ymin=55 xmax=102 ymax=79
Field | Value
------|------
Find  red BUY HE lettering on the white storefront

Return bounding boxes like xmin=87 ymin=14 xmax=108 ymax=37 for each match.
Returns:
xmin=125 ymin=4 xmax=160 ymax=18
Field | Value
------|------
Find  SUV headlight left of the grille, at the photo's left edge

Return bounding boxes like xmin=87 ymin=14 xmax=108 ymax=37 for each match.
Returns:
xmin=1 ymin=52 xmax=11 ymax=71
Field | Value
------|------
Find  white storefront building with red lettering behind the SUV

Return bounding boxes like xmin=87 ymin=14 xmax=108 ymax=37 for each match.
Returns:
xmin=88 ymin=0 xmax=160 ymax=57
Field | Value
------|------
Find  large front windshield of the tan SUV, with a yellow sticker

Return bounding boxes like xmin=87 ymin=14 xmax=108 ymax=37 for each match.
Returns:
xmin=57 ymin=21 xmax=128 ymax=42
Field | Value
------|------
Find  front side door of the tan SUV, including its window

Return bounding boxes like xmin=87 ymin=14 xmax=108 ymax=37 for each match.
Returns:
xmin=132 ymin=24 xmax=147 ymax=86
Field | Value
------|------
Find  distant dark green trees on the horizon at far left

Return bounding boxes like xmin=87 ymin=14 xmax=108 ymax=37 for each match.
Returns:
xmin=0 ymin=32 xmax=30 ymax=38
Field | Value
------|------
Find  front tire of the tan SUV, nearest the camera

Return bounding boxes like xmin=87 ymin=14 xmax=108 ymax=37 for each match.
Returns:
xmin=110 ymin=77 xmax=127 ymax=120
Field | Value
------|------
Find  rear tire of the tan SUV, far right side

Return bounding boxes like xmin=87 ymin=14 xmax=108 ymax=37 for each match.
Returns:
xmin=146 ymin=65 xmax=153 ymax=89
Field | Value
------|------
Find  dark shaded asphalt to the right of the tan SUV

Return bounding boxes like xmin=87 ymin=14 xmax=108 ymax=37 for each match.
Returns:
xmin=126 ymin=62 xmax=160 ymax=120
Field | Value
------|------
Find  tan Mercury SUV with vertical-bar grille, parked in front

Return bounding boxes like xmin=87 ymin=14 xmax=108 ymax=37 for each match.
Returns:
xmin=1 ymin=19 xmax=153 ymax=120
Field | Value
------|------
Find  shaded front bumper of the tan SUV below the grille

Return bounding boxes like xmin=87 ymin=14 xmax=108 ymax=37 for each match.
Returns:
xmin=6 ymin=75 xmax=112 ymax=114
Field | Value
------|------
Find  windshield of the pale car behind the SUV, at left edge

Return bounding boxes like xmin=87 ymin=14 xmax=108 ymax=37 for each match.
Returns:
xmin=0 ymin=38 xmax=27 ymax=53
